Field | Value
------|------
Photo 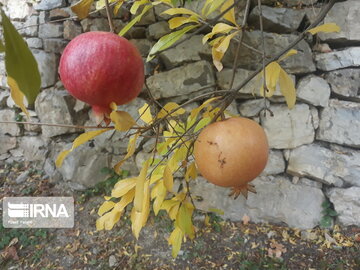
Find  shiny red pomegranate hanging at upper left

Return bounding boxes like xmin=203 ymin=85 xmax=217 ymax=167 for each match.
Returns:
xmin=59 ymin=32 xmax=144 ymax=116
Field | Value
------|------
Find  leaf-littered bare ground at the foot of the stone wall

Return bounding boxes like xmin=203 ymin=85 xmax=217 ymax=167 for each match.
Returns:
xmin=0 ymin=163 xmax=360 ymax=270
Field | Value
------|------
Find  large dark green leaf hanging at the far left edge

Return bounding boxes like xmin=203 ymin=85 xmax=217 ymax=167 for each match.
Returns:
xmin=1 ymin=11 xmax=41 ymax=104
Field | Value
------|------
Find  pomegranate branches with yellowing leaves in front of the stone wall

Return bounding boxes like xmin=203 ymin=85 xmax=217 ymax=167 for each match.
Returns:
xmin=1 ymin=0 xmax=337 ymax=257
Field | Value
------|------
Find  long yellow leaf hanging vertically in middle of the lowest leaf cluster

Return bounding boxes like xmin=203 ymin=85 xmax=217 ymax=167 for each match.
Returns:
xmin=131 ymin=180 xmax=150 ymax=239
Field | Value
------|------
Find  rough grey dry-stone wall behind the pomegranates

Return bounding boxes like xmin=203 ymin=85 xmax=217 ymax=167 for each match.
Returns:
xmin=0 ymin=0 xmax=360 ymax=228
